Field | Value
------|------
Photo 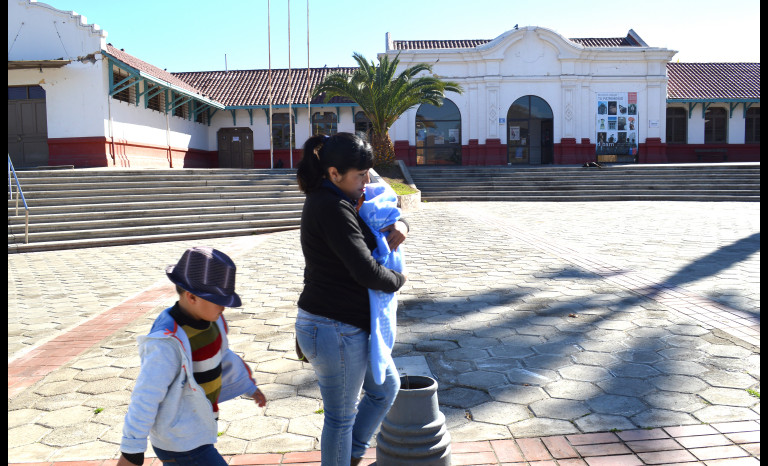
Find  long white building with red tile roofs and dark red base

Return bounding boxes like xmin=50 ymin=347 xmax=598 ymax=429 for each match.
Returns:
xmin=8 ymin=0 xmax=760 ymax=168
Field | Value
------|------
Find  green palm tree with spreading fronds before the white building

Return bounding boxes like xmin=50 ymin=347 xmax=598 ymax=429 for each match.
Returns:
xmin=313 ymin=53 xmax=463 ymax=167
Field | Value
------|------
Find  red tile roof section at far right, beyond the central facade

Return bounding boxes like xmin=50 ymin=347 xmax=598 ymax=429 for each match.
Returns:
xmin=667 ymin=63 xmax=760 ymax=99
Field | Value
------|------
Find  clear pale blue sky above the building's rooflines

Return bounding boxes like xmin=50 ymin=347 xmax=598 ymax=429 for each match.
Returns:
xmin=37 ymin=0 xmax=760 ymax=72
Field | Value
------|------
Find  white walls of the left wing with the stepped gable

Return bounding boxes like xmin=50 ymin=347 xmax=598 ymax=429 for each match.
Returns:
xmin=8 ymin=0 xmax=216 ymax=166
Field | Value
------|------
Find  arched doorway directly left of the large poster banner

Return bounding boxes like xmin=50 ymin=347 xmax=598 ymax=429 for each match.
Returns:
xmin=507 ymin=95 xmax=555 ymax=165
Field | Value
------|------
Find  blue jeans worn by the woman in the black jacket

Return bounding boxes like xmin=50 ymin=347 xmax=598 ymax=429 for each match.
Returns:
xmin=296 ymin=309 xmax=400 ymax=466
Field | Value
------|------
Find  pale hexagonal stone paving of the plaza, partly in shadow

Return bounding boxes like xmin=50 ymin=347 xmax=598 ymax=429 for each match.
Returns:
xmin=8 ymin=202 xmax=760 ymax=464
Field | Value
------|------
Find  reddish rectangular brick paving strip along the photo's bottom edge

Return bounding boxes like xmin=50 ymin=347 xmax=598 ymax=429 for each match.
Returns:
xmin=9 ymin=421 xmax=760 ymax=466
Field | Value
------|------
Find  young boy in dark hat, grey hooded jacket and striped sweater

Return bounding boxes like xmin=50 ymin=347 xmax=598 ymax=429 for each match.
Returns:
xmin=117 ymin=247 xmax=267 ymax=466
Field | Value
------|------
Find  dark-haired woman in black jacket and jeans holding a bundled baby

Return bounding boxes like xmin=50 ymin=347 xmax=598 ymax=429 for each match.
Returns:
xmin=296 ymin=133 xmax=408 ymax=466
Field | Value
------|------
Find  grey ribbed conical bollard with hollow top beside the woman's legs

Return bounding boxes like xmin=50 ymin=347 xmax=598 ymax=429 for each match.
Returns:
xmin=376 ymin=376 xmax=451 ymax=466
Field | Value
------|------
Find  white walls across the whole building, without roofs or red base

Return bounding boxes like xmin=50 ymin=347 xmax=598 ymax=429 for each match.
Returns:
xmin=8 ymin=0 xmax=759 ymax=167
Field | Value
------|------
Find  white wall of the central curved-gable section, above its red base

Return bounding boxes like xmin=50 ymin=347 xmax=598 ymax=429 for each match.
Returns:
xmin=386 ymin=26 xmax=676 ymax=145
